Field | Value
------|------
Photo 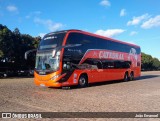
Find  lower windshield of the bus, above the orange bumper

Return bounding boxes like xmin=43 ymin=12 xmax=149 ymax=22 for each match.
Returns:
xmin=35 ymin=53 xmax=59 ymax=71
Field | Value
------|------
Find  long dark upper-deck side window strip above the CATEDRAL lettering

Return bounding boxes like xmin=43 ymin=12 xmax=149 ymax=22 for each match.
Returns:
xmin=66 ymin=33 xmax=140 ymax=54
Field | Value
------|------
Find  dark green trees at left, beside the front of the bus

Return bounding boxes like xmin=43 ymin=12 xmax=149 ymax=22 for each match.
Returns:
xmin=0 ymin=24 xmax=41 ymax=72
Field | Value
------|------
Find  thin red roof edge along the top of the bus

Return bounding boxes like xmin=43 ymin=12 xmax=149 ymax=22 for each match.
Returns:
xmin=45 ymin=29 xmax=140 ymax=48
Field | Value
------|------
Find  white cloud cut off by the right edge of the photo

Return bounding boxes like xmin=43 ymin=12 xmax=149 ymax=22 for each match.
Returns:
xmin=141 ymin=15 xmax=160 ymax=29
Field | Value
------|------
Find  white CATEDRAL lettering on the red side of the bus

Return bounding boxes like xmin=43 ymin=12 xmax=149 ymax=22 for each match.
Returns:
xmin=99 ymin=51 xmax=124 ymax=60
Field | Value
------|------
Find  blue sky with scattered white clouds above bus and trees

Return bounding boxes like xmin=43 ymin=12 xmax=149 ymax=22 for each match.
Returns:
xmin=0 ymin=0 xmax=160 ymax=59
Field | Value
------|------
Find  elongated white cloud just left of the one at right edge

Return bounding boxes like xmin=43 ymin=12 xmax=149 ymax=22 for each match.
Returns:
xmin=127 ymin=13 xmax=150 ymax=26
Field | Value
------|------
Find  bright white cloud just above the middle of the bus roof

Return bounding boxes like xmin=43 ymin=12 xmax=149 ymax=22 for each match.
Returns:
xmin=95 ymin=29 xmax=125 ymax=37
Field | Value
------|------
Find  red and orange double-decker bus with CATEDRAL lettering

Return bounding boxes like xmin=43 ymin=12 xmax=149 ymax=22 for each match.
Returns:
xmin=31 ymin=30 xmax=141 ymax=87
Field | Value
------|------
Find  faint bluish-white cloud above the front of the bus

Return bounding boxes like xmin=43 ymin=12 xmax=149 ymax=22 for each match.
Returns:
xmin=34 ymin=18 xmax=64 ymax=31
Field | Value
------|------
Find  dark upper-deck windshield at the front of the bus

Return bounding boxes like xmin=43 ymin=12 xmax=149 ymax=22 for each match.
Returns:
xmin=38 ymin=32 xmax=66 ymax=50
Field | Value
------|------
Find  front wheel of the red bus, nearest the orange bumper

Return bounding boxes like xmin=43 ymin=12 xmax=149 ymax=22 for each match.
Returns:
xmin=78 ymin=75 xmax=88 ymax=88
